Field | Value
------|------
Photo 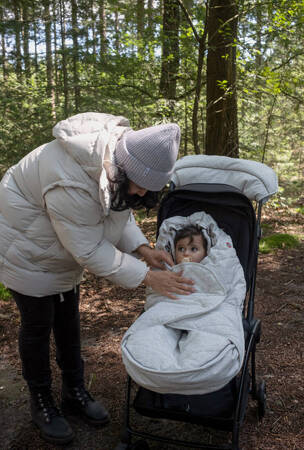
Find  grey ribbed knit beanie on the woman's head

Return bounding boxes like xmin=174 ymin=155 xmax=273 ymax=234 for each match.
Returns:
xmin=115 ymin=123 xmax=180 ymax=191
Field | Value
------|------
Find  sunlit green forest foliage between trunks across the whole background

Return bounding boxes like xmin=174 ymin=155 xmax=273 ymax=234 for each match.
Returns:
xmin=0 ymin=0 xmax=304 ymax=185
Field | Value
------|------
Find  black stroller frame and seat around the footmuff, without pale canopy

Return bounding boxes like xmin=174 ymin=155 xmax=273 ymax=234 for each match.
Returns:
xmin=116 ymin=183 xmax=266 ymax=450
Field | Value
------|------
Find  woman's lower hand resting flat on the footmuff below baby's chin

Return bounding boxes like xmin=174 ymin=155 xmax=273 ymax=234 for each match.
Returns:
xmin=144 ymin=270 xmax=195 ymax=300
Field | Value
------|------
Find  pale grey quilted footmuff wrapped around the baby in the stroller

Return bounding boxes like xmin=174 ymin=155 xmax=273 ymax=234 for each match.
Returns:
xmin=121 ymin=213 xmax=246 ymax=395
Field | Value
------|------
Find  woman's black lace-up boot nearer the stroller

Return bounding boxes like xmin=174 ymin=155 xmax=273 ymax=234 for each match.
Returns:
xmin=61 ymin=385 xmax=110 ymax=425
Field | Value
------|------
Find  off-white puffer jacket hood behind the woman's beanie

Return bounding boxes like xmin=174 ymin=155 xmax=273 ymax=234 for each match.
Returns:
xmin=53 ymin=112 xmax=130 ymax=213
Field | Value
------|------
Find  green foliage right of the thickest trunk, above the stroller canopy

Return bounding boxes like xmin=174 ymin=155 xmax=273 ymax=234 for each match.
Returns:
xmin=238 ymin=0 xmax=304 ymax=180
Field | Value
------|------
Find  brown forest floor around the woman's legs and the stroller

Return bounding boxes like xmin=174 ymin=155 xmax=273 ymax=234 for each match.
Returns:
xmin=0 ymin=202 xmax=304 ymax=450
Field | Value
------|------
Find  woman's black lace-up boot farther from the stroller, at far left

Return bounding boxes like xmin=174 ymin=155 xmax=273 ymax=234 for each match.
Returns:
xmin=31 ymin=389 xmax=74 ymax=444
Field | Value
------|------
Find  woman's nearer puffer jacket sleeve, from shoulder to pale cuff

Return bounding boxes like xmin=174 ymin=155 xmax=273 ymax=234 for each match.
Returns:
xmin=44 ymin=187 xmax=149 ymax=288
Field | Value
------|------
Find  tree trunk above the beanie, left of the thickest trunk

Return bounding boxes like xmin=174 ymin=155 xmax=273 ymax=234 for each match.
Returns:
xmin=159 ymin=0 xmax=180 ymax=100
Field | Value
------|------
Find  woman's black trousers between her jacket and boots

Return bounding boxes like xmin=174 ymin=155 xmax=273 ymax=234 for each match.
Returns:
xmin=11 ymin=286 xmax=84 ymax=392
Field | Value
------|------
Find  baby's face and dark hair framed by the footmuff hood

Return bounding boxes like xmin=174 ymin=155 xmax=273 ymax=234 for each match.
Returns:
xmin=174 ymin=225 xmax=207 ymax=264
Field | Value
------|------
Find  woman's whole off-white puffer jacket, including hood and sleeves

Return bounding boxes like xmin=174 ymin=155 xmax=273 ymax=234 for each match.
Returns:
xmin=0 ymin=113 xmax=148 ymax=297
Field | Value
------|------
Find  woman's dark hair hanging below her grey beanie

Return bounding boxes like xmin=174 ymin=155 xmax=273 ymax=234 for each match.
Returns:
xmin=108 ymin=166 xmax=159 ymax=211
